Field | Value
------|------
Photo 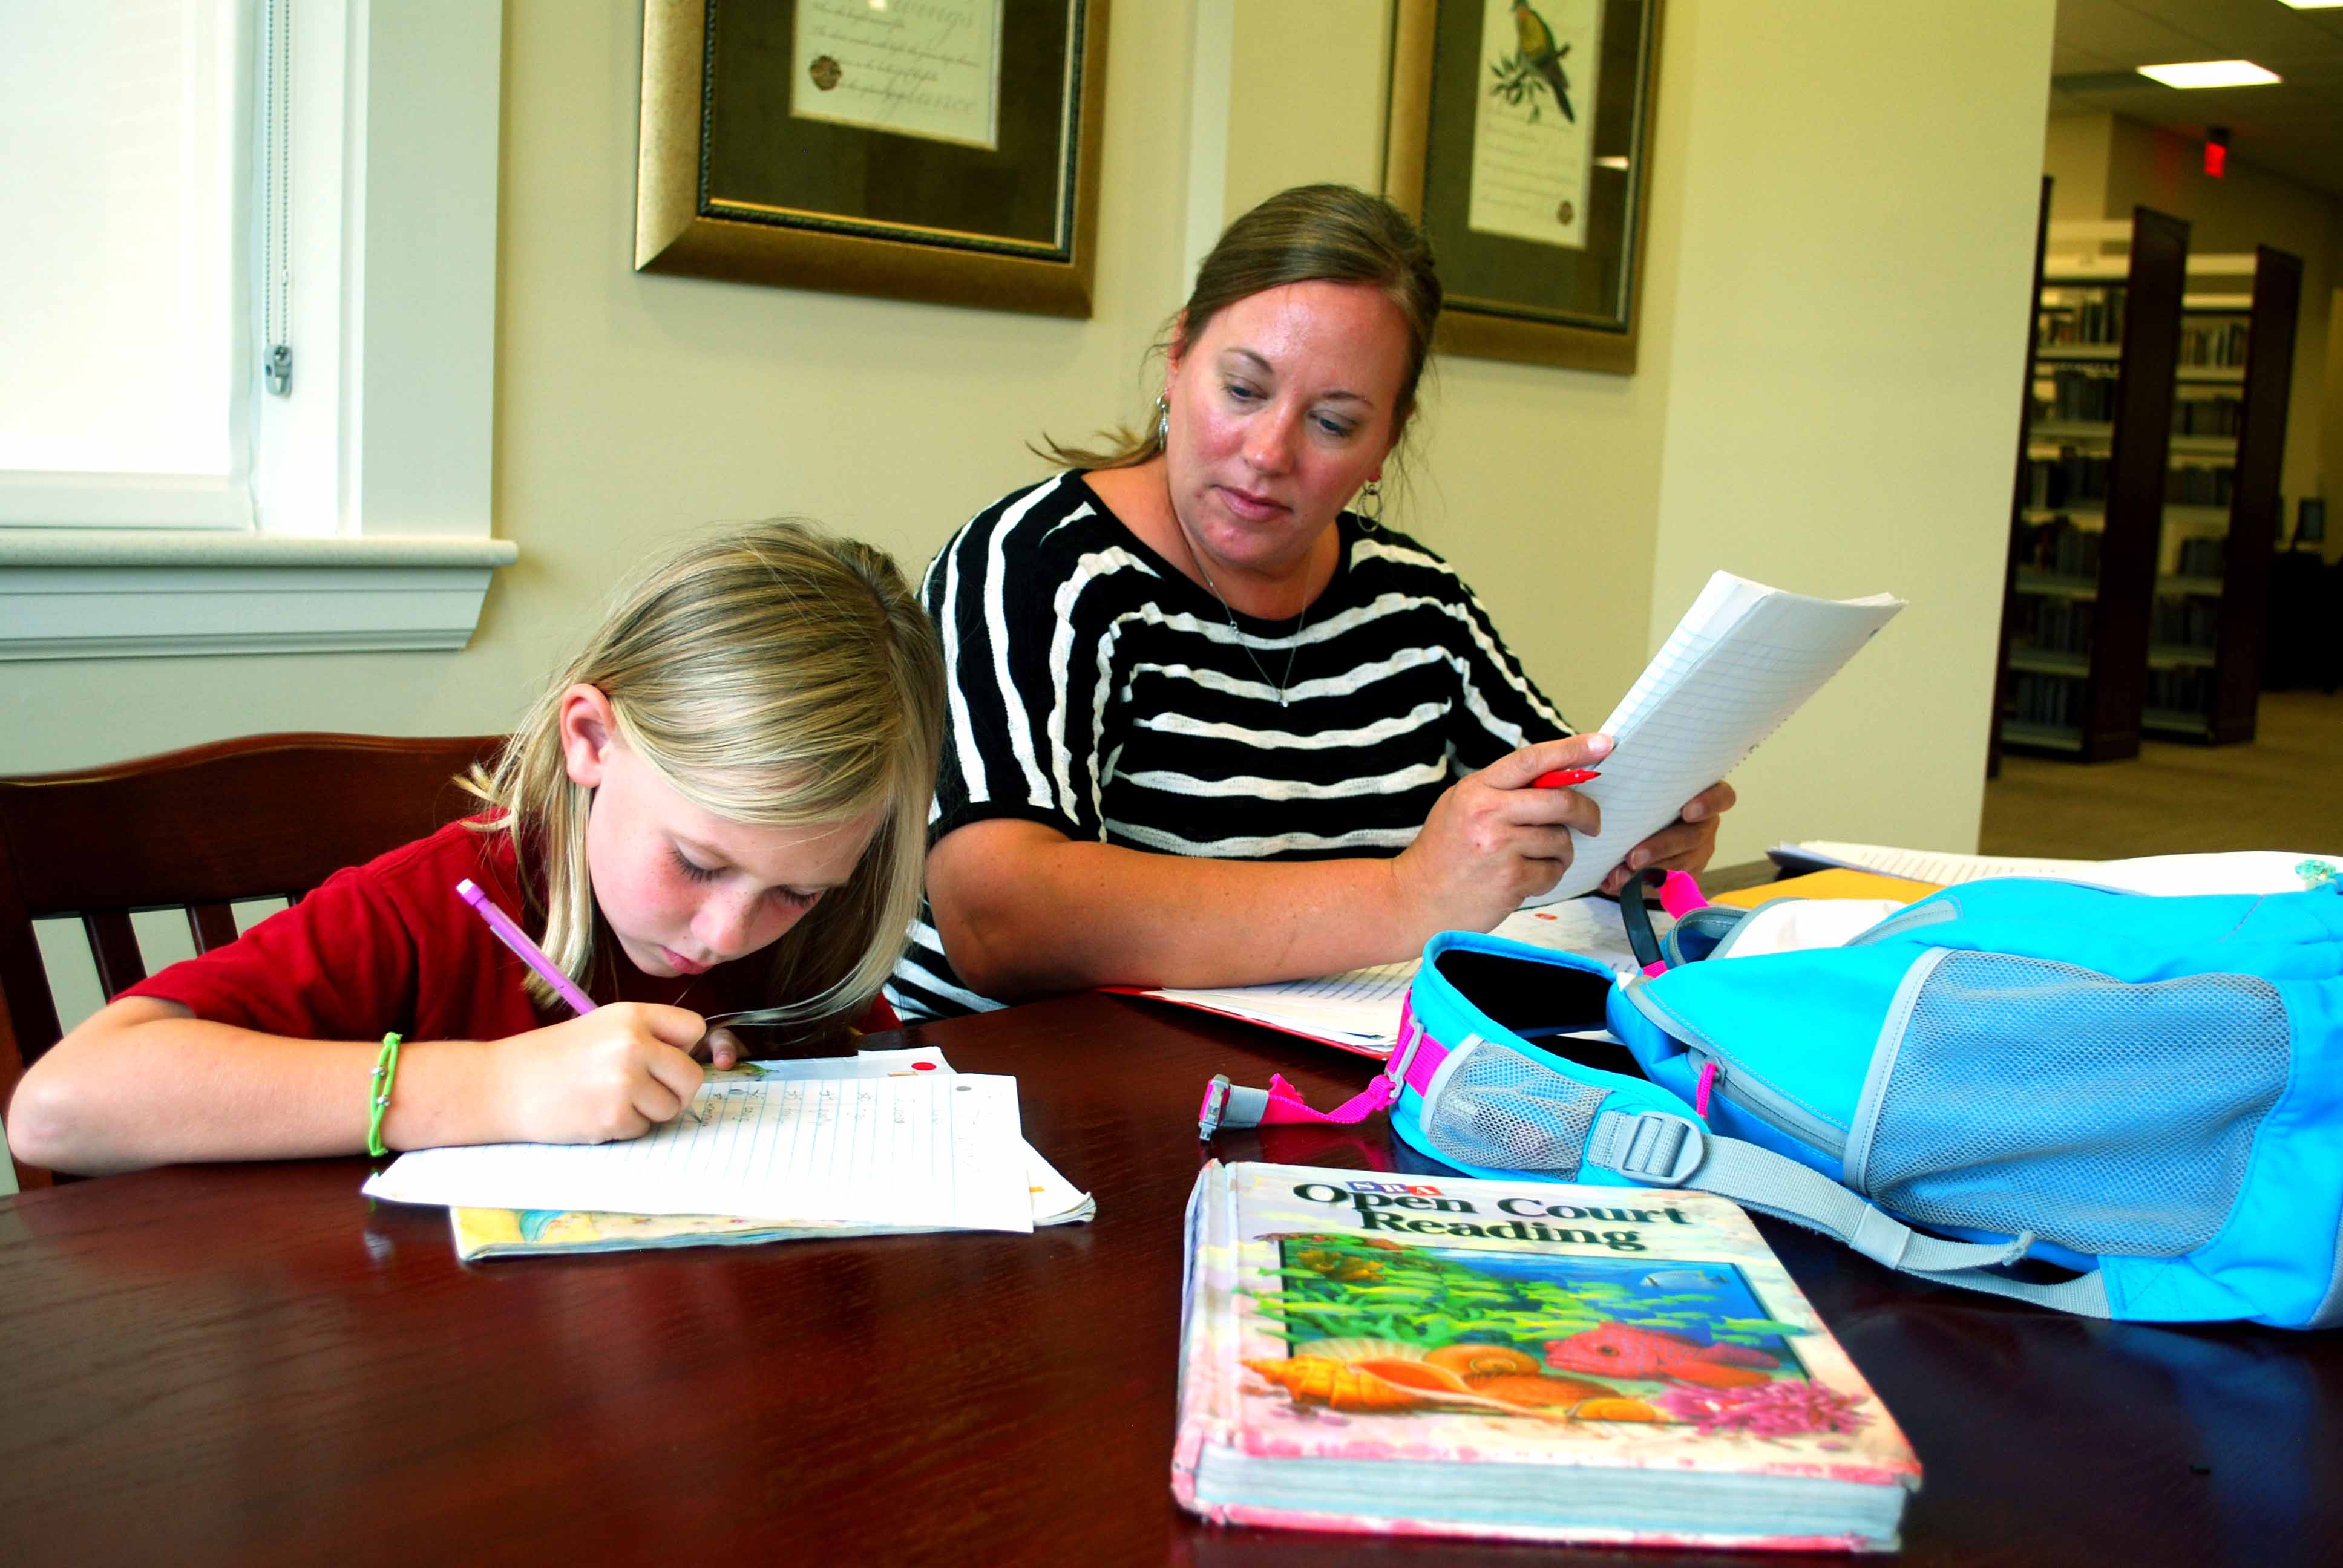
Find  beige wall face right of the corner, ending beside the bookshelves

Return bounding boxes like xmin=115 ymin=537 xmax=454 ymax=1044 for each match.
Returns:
xmin=1650 ymin=0 xmax=2053 ymax=860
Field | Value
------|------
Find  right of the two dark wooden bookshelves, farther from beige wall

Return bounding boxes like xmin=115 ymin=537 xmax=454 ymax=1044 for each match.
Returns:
xmin=2139 ymin=246 xmax=2303 ymax=745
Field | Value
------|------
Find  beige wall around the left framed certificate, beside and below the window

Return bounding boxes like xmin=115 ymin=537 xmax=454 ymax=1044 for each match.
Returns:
xmin=0 ymin=0 xmax=1188 ymax=771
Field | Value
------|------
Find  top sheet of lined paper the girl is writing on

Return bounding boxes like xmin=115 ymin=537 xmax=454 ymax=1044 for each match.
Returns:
xmin=365 ymin=1073 xmax=1034 ymax=1230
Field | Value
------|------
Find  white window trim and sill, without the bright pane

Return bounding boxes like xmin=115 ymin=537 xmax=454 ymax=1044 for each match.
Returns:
xmin=0 ymin=0 xmax=518 ymax=661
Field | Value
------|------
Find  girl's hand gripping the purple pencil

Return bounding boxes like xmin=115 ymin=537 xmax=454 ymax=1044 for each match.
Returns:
xmin=492 ymin=1001 xmax=707 ymax=1144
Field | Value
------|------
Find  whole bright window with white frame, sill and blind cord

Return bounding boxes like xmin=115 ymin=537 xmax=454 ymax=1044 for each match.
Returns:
xmin=0 ymin=0 xmax=516 ymax=659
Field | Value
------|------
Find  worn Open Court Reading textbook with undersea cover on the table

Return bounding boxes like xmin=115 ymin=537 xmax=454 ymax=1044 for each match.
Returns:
xmin=1172 ymin=1165 xmax=1919 ymax=1552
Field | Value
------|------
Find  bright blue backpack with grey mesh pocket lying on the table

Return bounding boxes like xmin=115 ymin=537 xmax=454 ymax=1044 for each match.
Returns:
xmin=1392 ymin=879 xmax=2343 ymax=1327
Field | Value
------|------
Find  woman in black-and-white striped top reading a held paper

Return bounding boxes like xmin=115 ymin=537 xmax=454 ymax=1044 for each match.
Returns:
xmin=888 ymin=185 xmax=1734 ymax=1018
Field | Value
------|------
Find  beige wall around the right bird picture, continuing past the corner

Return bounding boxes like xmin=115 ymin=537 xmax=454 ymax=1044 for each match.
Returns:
xmin=1225 ymin=0 xmax=2053 ymax=860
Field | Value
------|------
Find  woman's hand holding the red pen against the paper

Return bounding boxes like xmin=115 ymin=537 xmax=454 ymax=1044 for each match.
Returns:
xmin=1392 ymin=736 xmax=1612 ymax=933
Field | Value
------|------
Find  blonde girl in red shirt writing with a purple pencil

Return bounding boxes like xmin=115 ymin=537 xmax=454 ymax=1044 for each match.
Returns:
xmin=7 ymin=523 xmax=944 ymax=1172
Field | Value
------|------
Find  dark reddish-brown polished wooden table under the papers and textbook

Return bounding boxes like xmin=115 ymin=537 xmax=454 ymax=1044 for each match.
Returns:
xmin=0 ymin=996 xmax=2343 ymax=1568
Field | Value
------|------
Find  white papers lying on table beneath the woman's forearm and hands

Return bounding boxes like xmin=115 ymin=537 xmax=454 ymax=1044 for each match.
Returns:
xmin=1136 ymin=898 xmax=1668 ymax=1057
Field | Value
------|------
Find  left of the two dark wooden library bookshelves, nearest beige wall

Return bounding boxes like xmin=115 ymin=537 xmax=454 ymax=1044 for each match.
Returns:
xmin=1994 ymin=209 xmax=2188 ymax=762
